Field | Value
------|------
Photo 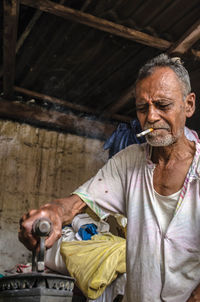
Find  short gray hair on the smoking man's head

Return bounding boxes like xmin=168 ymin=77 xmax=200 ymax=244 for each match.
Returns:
xmin=135 ymin=53 xmax=191 ymax=99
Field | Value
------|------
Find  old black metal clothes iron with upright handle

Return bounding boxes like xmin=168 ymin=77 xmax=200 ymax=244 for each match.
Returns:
xmin=0 ymin=218 xmax=74 ymax=302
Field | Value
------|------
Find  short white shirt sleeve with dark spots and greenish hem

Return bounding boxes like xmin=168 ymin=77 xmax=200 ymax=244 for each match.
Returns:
xmin=73 ymin=156 xmax=126 ymax=219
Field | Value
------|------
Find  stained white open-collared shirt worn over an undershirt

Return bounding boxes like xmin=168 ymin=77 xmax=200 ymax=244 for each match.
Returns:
xmin=74 ymin=143 xmax=200 ymax=302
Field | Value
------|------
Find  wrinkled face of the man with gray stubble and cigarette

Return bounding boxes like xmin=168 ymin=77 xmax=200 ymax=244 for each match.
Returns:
xmin=136 ymin=67 xmax=191 ymax=146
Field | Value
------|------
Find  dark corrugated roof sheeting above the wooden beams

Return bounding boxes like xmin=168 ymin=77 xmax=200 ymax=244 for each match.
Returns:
xmin=0 ymin=0 xmax=200 ymax=137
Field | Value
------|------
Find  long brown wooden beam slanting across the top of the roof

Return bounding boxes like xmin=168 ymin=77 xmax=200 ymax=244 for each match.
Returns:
xmin=20 ymin=0 xmax=171 ymax=50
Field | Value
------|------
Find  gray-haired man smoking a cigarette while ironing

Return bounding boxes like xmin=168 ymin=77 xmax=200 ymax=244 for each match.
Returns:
xmin=19 ymin=54 xmax=200 ymax=302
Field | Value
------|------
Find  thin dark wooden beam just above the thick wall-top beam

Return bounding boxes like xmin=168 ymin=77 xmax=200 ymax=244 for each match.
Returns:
xmin=14 ymin=86 xmax=132 ymax=122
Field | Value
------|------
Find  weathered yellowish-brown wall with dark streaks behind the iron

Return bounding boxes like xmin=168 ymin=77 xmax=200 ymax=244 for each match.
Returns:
xmin=0 ymin=121 xmax=107 ymax=273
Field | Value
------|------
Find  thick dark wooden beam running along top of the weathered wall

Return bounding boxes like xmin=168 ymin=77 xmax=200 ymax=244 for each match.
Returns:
xmin=0 ymin=98 xmax=116 ymax=140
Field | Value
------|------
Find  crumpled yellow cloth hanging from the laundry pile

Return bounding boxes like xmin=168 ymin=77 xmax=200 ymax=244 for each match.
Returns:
xmin=60 ymin=233 xmax=126 ymax=299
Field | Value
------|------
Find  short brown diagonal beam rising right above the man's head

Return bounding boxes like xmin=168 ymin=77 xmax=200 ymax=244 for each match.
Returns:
xmin=168 ymin=19 xmax=200 ymax=54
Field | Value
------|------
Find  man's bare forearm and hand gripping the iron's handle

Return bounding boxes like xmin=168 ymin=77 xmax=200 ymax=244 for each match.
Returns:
xmin=18 ymin=195 xmax=86 ymax=250
